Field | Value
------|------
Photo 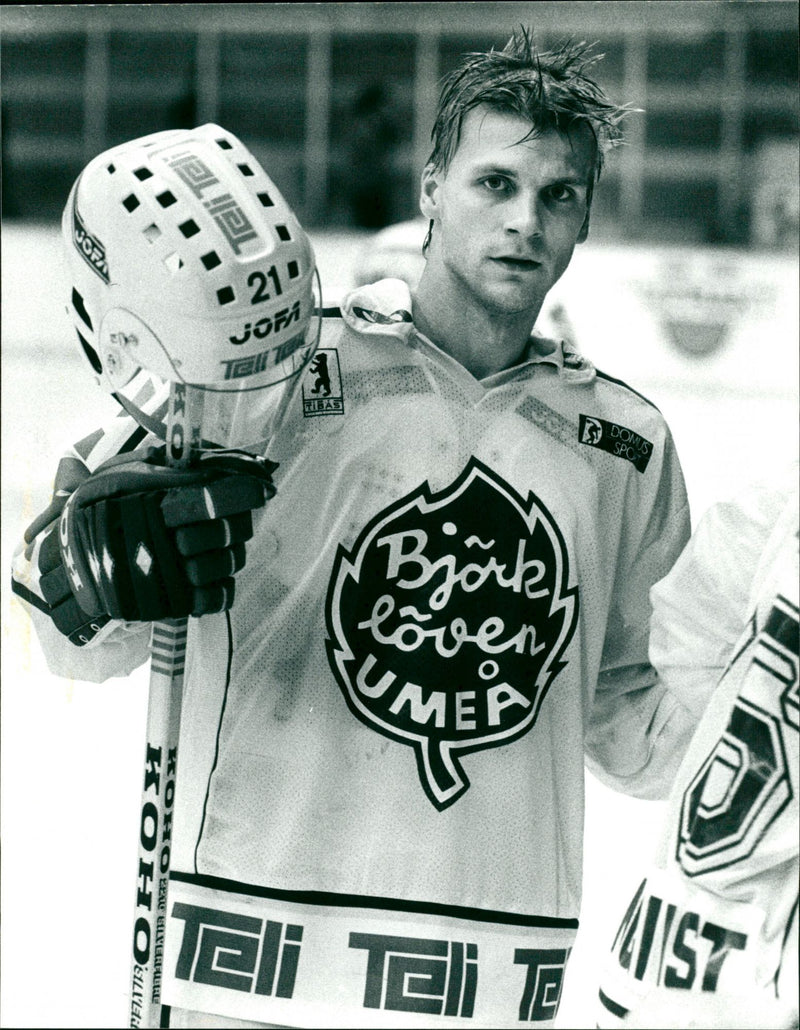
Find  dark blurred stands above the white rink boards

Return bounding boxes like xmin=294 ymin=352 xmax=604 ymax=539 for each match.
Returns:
xmin=2 ymin=0 xmax=798 ymax=241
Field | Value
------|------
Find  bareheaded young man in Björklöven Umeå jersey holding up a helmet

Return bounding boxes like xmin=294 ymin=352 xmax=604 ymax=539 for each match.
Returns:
xmin=10 ymin=33 xmax=694 ymax=1028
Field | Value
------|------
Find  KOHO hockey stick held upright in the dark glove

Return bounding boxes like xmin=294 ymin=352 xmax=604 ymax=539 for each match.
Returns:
xmin=130 ymin=383 xmax=204 ymax=1027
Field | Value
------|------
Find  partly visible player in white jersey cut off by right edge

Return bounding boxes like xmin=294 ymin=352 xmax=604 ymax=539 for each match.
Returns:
xmin=598 ymin=468 xmax=800 ymax=1030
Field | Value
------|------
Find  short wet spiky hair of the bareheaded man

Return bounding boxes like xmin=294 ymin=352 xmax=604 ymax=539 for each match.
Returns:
xmin=428 ymin=27 xmax=630 ymax=191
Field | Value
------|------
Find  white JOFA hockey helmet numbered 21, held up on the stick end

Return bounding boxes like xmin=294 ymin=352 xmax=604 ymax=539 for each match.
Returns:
xmin=62 ymin=125 xmax=321 ymax=444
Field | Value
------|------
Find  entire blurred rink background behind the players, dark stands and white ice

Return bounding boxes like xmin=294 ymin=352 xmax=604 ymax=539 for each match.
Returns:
xmin=0 ymin=0 xmax=800 ymax=1028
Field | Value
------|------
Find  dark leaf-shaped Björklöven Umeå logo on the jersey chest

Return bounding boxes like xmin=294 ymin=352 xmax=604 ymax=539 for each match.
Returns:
xmin=326 ymin=458 xmax=579 ymax=811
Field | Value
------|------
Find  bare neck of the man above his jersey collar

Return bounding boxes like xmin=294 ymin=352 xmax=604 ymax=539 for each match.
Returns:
xmin=412 ymin=265 xmax=538 ymax=379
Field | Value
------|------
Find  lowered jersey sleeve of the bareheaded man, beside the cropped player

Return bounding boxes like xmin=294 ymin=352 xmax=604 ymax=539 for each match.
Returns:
xmin=585 ymin=418 xmax=706 ymax=799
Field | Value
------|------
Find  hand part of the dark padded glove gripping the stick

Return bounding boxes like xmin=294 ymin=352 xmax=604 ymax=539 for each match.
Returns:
xmin=59 ymin=447 xmax=277 ymax=622
